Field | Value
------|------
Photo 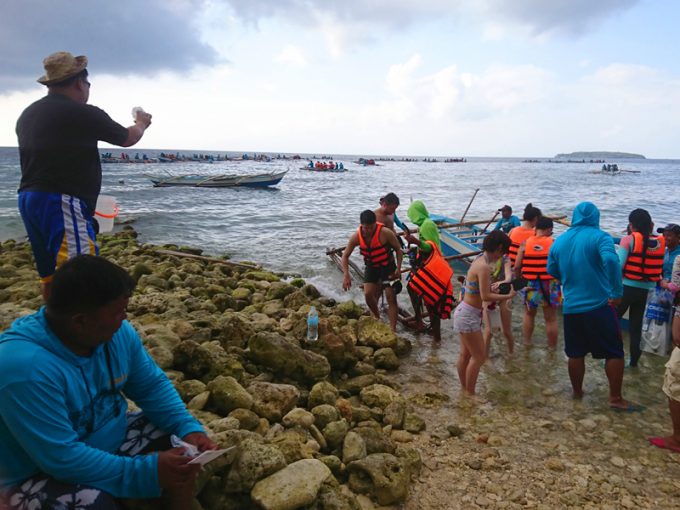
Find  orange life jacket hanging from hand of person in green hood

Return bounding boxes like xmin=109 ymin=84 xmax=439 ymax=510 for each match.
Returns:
xmin=408 ymin=241 xmax=453 ymax=319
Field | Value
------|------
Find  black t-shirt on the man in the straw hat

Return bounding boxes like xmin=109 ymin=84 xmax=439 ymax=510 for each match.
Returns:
xmin=16 ymin=94 xmax=128 ymax=213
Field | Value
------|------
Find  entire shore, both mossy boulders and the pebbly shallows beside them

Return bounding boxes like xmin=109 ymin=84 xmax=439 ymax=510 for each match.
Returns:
xmin=0 ymin=230 xmax=680 ymax=510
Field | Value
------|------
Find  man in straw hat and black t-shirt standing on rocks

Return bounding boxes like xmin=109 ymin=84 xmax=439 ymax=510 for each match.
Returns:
xmin=16 ymin=51 xmax=151 ymax=299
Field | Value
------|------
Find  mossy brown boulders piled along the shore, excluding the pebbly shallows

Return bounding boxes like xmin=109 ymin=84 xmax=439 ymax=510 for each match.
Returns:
xmin=0 ymin=229 xmax=425 ymax=510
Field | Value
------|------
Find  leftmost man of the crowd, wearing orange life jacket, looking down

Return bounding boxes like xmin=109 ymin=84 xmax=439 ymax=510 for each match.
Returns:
xmin=342 ymin=209 xmax=403 ymax=331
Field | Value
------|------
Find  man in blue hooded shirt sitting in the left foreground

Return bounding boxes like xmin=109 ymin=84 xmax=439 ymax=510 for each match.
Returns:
xmin=0 ymin=255 xmax=217 ymax=509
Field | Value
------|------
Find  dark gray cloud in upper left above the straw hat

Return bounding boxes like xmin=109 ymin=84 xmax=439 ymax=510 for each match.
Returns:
xmin=0 ymin=0 xmax=218 ymax=93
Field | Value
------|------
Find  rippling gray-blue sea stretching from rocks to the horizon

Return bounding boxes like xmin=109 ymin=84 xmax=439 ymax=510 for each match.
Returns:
xmin=0 ymin=148 xmax=680 ymax=299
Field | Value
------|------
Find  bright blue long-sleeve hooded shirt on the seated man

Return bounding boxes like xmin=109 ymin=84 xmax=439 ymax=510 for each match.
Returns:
xmin=0 ymin=308 xmax=204 ymax=498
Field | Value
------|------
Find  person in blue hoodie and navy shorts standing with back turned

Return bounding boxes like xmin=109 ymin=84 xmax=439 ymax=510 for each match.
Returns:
xmin=548 ymin=202 xmax=637 ymax=411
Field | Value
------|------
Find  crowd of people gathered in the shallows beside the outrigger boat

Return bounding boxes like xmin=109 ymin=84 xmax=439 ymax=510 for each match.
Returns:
xmin=341 ymin=193 xmax=680 ymax=452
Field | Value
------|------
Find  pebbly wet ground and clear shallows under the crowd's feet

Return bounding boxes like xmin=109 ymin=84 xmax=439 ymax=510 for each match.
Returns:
xmin=392 ymin=310 xmax=680 ymax=510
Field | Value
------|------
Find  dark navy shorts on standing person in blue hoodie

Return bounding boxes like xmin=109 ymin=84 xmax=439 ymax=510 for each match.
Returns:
xmin=564 ymin=305 xmax=623 ymax=359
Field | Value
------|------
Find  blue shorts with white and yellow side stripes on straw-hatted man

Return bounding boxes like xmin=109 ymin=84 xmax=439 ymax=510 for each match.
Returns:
xmin=19 ymin=191 xmax=99 ymax=282
